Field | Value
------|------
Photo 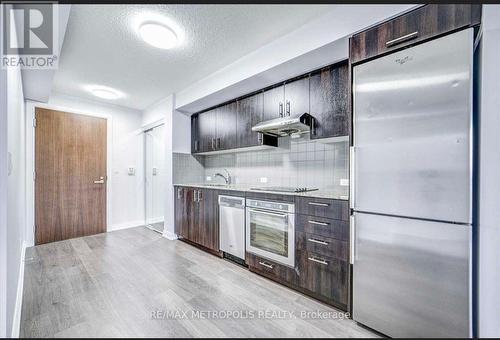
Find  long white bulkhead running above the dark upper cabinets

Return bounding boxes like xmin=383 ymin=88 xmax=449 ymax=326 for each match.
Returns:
xmin=176 ymin=5 xmax=414 ymax=111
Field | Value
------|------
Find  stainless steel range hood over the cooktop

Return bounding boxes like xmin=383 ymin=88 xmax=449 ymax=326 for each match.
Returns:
xmin=252 ymin=113 xmax=314 ymax=137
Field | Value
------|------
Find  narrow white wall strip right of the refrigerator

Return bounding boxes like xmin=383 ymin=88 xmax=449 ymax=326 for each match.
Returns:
xmin=478 ymin=5 xmax=500 ymax=337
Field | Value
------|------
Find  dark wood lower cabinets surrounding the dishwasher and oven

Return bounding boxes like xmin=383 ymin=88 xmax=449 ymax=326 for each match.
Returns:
xmin=175 ymin=186 xmax=350 ymax=311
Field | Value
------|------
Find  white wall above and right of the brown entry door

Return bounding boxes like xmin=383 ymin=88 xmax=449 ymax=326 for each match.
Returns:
xmin=28 ymin=93 xmax=144 ymax=231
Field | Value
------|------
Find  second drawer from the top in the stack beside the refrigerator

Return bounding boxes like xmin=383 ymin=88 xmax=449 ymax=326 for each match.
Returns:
xmin=295 ymin=215 xmax=349 ymax=241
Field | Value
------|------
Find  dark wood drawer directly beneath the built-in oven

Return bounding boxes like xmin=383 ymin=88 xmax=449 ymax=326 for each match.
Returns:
xmin=246 ymin=252 xmax=297 ymax=285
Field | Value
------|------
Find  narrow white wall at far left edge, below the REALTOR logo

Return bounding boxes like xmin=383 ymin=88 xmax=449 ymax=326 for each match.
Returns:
xmin=0 ymin=8 xmax=26 ymax=336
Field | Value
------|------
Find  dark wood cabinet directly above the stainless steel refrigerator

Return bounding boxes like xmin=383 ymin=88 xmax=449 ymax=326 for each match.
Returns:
xmin=350 ymin=4 xmax=481 ymax=64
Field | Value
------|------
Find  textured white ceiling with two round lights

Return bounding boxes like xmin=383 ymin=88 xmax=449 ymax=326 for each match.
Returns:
xmin=53 ymin=5 xmax=332 ymax=109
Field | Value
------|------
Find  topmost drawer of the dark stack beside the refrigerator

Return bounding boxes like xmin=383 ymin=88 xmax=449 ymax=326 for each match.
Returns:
xmin=295 ymin=197 xmax=349 ymax=221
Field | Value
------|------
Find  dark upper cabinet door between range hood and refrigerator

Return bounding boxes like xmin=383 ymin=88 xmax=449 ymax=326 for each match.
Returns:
xmin=310 ymin=62 xmax=351 ymax=139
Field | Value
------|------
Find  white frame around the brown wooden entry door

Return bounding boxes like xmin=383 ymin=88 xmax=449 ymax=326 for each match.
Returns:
xmin=26 ymin=101 xmax=113 ymax=247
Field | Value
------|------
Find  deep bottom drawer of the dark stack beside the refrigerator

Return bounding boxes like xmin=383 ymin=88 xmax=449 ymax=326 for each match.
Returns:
xmin=297 ymin=251 xmax=349 ymax=310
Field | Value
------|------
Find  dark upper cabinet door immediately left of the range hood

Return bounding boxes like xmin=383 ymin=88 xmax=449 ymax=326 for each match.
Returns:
xmin=237 ymin=93 xmax=264 ymax=148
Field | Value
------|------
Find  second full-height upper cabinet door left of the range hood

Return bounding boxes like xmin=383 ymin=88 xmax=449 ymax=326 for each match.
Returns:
xmin=215 ymin=101 xmax=238 ymax=150
